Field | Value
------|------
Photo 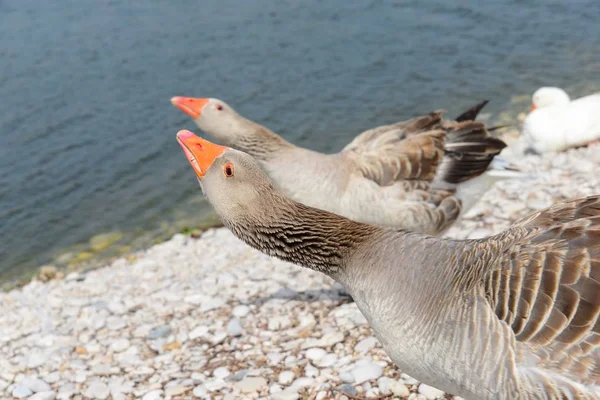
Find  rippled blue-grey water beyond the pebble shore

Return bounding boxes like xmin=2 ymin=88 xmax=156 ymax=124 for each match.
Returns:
xmin=0 ymin=0 xmax=600 ymax=279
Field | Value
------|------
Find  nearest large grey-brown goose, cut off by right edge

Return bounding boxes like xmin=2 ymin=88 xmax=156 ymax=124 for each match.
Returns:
xmin=177 ymin=130 xmax=600 ymax=400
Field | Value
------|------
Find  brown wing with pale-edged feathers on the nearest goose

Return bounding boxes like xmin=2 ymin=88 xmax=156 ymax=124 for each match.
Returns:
xmin=484 ymin=196 xmax=600 ymax=383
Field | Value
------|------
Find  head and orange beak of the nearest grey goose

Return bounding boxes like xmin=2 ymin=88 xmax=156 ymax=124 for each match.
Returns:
xmin=177 ymin=130 xmax=274 ymax=222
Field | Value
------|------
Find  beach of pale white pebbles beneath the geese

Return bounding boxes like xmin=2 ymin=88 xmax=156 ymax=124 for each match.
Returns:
xmin=0 ymin=146 xmax=600 ymax=400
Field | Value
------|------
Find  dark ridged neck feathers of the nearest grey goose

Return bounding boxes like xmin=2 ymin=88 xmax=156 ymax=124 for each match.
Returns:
xmin=224 ymin=193 xmax=380 ymax=276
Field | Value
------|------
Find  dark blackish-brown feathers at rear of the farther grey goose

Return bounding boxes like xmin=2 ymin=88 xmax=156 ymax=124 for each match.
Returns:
xmin=435 ymin=121 xmax=506 ymax=187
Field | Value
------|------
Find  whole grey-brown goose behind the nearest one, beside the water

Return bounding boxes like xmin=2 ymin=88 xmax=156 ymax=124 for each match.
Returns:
xmin=171 ymin=97 xmax=519 ymax=235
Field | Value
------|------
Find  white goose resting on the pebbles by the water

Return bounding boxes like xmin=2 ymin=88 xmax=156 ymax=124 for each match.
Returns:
xmin=523 ymin=87 xmax=600 ymax=153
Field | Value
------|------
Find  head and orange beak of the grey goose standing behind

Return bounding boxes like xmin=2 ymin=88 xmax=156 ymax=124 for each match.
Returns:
xmin=171 ymin=96 xmax=250 ymax=146
